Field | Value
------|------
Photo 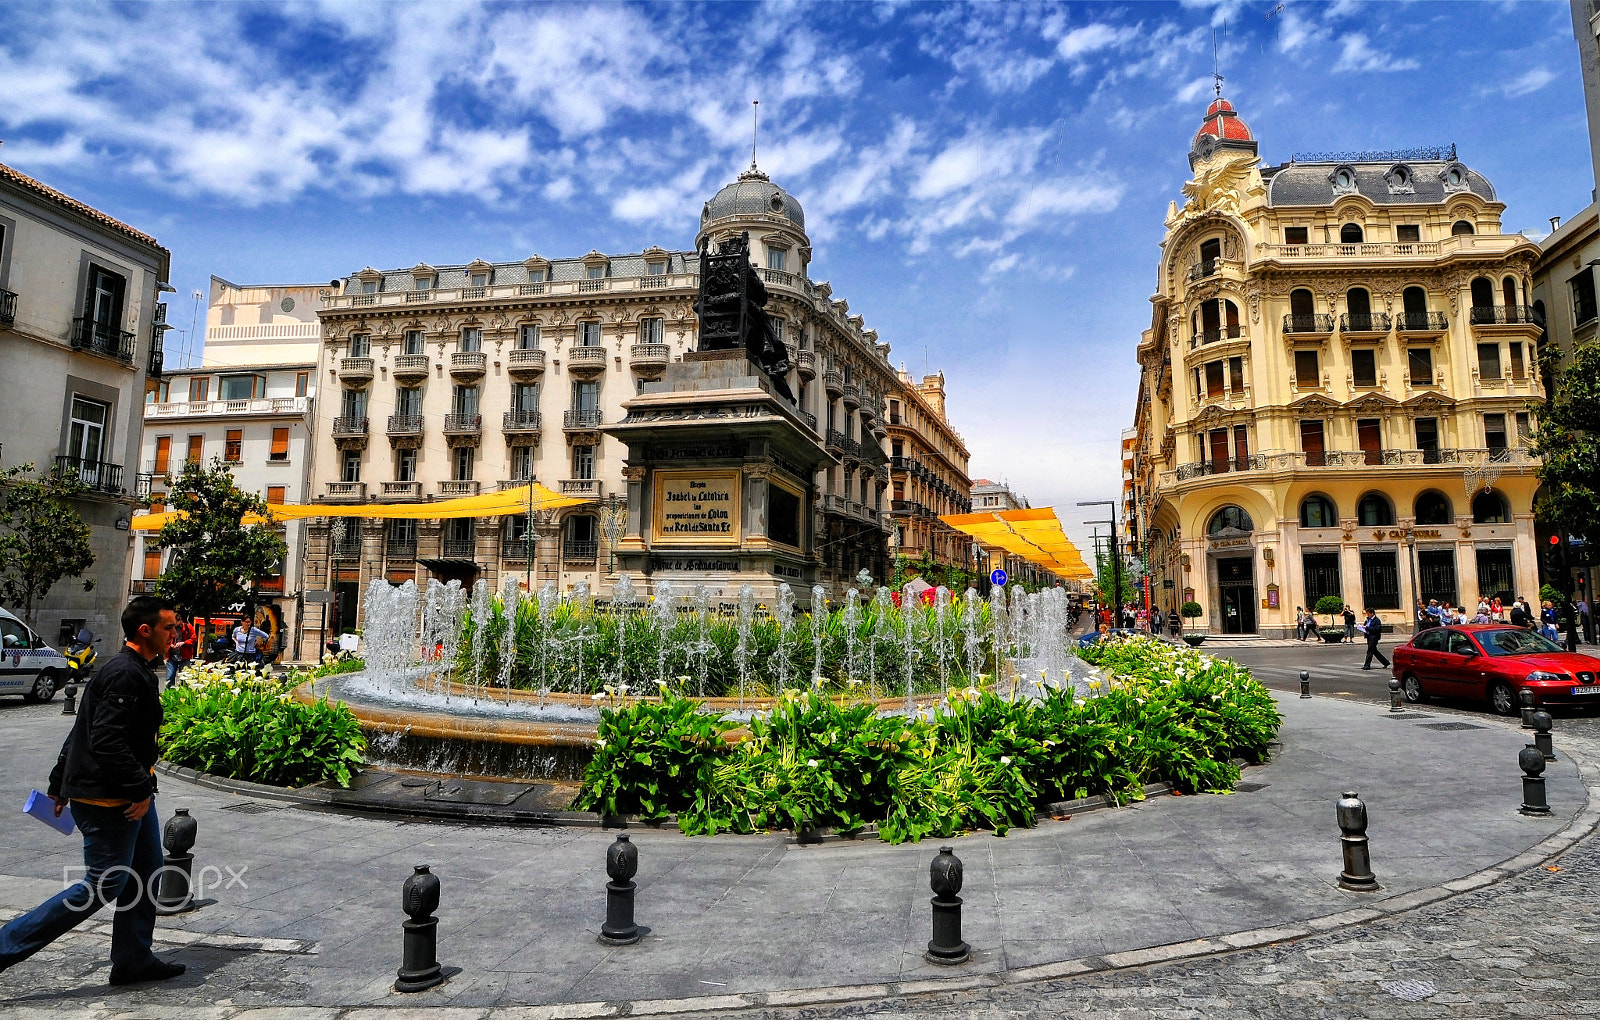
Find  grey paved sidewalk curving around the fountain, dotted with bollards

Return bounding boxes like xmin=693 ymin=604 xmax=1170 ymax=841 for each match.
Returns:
xmin=0 ymin=699 xmax=1592 ymax=1018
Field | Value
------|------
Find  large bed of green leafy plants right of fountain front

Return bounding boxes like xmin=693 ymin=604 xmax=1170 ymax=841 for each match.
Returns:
xmin=574 ymin=638 xmax=1282 ymax=843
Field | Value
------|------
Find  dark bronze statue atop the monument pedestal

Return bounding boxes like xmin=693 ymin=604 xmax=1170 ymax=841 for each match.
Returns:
xmin=694 ymin=233 xmax=794 ymax=403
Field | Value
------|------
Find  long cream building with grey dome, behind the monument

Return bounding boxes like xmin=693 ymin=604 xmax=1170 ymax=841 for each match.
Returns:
xmin=304 ymin=168 xmax=898 ymax=645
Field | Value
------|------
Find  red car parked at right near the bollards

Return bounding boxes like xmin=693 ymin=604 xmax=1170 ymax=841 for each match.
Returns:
xmin=1394 ymin=625 xmax=1600 ymax=715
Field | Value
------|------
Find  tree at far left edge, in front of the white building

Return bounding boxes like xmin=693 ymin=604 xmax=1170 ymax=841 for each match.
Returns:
xmin=0 ymin=464 xmax=94 ymax=624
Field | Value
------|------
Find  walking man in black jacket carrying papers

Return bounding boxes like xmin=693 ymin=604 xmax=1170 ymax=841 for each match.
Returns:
xmin=0 ymin=595 xmax=184 ymax=985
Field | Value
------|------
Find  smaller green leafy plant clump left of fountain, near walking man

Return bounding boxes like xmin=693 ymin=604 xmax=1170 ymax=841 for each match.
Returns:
xmin=158 ymin=663 xmax=366 ymax=787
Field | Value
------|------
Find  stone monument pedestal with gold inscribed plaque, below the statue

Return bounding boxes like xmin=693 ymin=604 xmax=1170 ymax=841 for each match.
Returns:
xmin=603 ymin=350 xmax=838 ymax=603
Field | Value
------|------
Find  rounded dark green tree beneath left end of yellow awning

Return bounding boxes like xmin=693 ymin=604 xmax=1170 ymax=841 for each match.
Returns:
xmin=155 ymin=457 xmax=288 ymax=642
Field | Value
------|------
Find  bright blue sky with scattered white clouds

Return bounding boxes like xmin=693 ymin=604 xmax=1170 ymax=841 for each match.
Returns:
xmin=0 ymin=0 xmax=1594 ymax=553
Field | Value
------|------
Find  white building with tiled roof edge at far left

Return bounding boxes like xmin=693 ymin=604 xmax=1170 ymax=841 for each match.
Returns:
xmin=0 ymin=165 xmax=171 ymax=647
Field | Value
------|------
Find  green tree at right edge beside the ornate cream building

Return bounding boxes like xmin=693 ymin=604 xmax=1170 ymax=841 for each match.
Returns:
xmin=1533 ymin=344 xmax=1600 ymax=559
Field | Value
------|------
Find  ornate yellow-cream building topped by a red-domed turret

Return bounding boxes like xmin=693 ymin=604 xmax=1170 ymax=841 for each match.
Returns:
xmin=1134 ymin=98 xmax=1542 ymax=635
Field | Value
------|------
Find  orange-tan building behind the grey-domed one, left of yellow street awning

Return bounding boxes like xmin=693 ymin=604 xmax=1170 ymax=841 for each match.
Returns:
xmin=888 ymin=374 xmax=976 ymax=572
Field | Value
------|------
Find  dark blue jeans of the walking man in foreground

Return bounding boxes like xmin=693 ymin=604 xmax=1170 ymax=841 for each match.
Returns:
xmin=0 ymin=799 xmax=162 ymax=972
